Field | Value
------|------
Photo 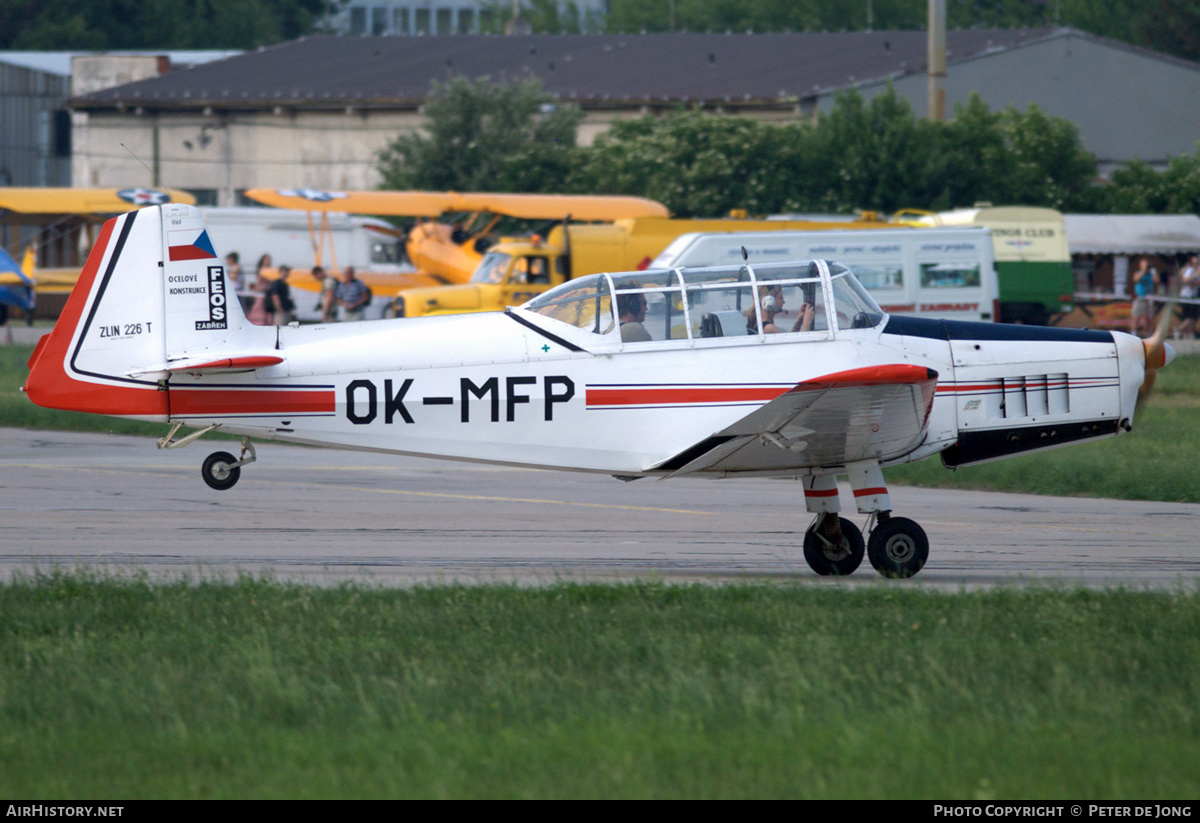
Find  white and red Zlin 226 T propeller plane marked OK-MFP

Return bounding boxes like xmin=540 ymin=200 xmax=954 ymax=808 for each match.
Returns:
xmin=25 ymin=205 xmax=1174 ymax=577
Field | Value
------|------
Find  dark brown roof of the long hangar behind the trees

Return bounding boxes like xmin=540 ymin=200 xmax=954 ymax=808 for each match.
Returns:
xmin=71 ymin=29 xmax=1060 ymax=109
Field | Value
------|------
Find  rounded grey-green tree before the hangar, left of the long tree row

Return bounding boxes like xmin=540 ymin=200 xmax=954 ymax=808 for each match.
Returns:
xmin=379 ymin=77 xmax=582 ymax=192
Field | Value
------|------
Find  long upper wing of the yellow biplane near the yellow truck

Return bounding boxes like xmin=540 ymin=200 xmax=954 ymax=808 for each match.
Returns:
xmin=246 ymin=188 xmax=670 ymax=221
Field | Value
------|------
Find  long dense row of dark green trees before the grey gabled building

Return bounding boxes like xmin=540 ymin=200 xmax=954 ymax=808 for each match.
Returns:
xmin=571 ymin=89 xmax=1096 ymax=217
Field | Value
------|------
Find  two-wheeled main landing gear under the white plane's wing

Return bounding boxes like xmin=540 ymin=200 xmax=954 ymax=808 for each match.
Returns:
xmin=804 ymin=463 xmax=929 ymax=578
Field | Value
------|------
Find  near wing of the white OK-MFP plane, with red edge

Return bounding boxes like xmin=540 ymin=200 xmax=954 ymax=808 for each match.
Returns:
xmin=655 ymin=364 xmax=937 ymax=476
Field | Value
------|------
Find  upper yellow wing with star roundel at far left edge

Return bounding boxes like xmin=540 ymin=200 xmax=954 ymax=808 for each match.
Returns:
xmin=0 ymin=186 xmax=196 ymax=223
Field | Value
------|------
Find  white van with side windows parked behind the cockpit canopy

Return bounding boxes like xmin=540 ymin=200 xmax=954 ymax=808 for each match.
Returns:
xmin=649 ymin=228 xmax=1000 ymax=322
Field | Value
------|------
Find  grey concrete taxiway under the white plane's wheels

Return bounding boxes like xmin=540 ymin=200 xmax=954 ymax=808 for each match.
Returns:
xmin=0 ymin=427 xmax=1200 ymax=589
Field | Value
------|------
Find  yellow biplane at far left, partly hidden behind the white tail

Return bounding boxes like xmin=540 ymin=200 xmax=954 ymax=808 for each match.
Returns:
xmin=0 ymin=186 xmax=196 ymax=317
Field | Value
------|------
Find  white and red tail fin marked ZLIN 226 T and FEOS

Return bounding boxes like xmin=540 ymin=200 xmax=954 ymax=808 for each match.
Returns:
xmin=25 ymin=204 xmax=274 ymax=420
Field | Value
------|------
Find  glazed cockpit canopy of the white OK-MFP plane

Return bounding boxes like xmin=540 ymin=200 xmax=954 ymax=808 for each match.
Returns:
xmin=521 ymin=260 xmax=884 ymax=343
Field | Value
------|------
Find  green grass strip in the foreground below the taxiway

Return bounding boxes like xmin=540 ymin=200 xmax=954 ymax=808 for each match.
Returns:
xmin=7 ymin=576 xmax=1200 ymax=799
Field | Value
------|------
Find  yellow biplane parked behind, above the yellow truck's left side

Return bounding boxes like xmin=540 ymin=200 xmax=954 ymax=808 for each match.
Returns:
xmin=246 ymin=188 xmax=668 ymax=296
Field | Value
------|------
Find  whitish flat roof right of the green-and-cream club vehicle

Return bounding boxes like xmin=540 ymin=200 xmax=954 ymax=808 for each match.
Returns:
xmin=1063 ymin=215 xmax=1200 ymax=254
